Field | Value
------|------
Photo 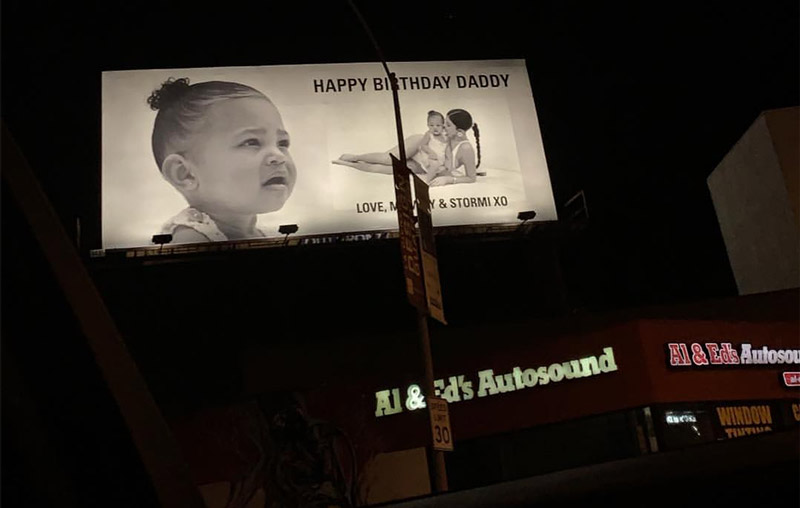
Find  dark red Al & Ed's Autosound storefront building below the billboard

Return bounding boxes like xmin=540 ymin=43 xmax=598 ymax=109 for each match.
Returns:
xmin=173 ymin=290 xmax=800 ymax=504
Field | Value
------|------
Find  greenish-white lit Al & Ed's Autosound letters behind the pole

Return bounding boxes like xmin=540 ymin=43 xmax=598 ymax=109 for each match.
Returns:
xmin=375 ymin=347 xmax=617 ymax=417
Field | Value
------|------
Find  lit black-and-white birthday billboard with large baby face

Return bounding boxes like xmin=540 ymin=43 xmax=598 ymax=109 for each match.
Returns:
xmin=102 ymin=60 xmax=556 ymax=249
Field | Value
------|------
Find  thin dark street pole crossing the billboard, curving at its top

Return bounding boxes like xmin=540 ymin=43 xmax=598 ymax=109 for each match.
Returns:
xmin=348 ymin=0 xmax=448 ymax=492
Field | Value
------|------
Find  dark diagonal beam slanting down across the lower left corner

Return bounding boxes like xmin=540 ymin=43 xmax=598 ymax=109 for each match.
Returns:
xmin=2 ymin=124 xmax=205 ymax=508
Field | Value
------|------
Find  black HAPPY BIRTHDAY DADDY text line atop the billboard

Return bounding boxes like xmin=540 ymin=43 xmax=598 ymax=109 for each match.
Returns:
xmin=313 ymin=74 xmax=509 ymax=93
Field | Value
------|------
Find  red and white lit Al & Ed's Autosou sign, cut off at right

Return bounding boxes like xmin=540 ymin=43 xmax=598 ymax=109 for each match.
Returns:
xmin=667 ymin=342 xmax=800 ymax=367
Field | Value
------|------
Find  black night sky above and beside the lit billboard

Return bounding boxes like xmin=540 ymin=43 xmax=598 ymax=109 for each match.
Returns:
xmin=2 ymin=0 xmax=800 ymax=304
